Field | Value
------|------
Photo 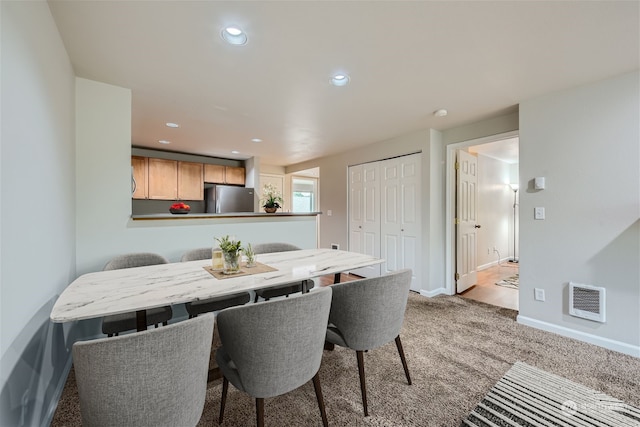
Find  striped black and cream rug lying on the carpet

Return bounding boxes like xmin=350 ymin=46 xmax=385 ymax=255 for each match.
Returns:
xmin=462 ymin=362 xmax=640 ymax=427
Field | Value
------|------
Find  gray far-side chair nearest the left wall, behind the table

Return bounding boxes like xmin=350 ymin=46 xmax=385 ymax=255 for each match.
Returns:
xmin=102 ymin=252 xmax=173 ymax=337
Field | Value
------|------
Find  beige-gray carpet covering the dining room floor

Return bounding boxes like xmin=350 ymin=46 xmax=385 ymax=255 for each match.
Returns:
xmin=52 ymin=293 xmax=640 ymax=427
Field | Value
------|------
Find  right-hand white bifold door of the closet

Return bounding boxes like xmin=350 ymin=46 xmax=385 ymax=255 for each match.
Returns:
xmin=380 ymin=154 xmax=422 ymax=291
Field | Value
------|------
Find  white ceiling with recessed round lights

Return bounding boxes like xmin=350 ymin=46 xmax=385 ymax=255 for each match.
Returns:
xmin=49 ymin=0 xmax=640 ymax=166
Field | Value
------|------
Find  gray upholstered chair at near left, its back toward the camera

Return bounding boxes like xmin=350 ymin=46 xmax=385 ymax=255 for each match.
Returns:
xmin=73 ymin=314 xmax=214 ymax=427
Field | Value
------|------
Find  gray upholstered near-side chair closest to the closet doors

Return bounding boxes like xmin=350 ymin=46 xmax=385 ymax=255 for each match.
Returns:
xmin=327 ymin=270 xmax=411 ymax=416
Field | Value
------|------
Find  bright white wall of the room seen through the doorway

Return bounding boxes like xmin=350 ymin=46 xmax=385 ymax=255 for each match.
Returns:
xmin=477 ymin=154 xmax=517 ymax=268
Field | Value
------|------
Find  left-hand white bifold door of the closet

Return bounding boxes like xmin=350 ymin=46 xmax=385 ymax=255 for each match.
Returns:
xmin=349 ymin=162 xmax=380 ymax=277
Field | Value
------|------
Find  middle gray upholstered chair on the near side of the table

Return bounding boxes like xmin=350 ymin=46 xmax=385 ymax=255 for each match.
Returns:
xmin=216 ymin=287 xmax=331 ymax=426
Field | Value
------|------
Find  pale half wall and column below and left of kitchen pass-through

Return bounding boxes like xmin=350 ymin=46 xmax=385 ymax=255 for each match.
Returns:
xmin=76 ymin=78 xmax=317 ymax=275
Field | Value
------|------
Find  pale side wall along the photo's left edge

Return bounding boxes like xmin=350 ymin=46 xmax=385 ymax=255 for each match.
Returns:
xmin=0 ymin=1 xmax=75 ymax=426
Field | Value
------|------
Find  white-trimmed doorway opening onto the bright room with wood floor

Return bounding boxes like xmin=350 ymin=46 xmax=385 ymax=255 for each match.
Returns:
xmin=446 ymin=132 xmax=519 ymax=309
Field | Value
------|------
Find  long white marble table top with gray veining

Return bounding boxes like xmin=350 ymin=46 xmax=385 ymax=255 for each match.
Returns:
xmin=50 ymin=249 xmax=384 ymax=323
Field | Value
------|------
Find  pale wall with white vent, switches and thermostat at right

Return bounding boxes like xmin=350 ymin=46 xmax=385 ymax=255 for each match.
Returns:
xmin=519 ymin=71 xmax=640 ymax=356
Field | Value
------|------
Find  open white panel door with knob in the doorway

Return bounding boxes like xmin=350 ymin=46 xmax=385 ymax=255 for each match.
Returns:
xmin=456 ymin=150 xmax=480 ymax=293
